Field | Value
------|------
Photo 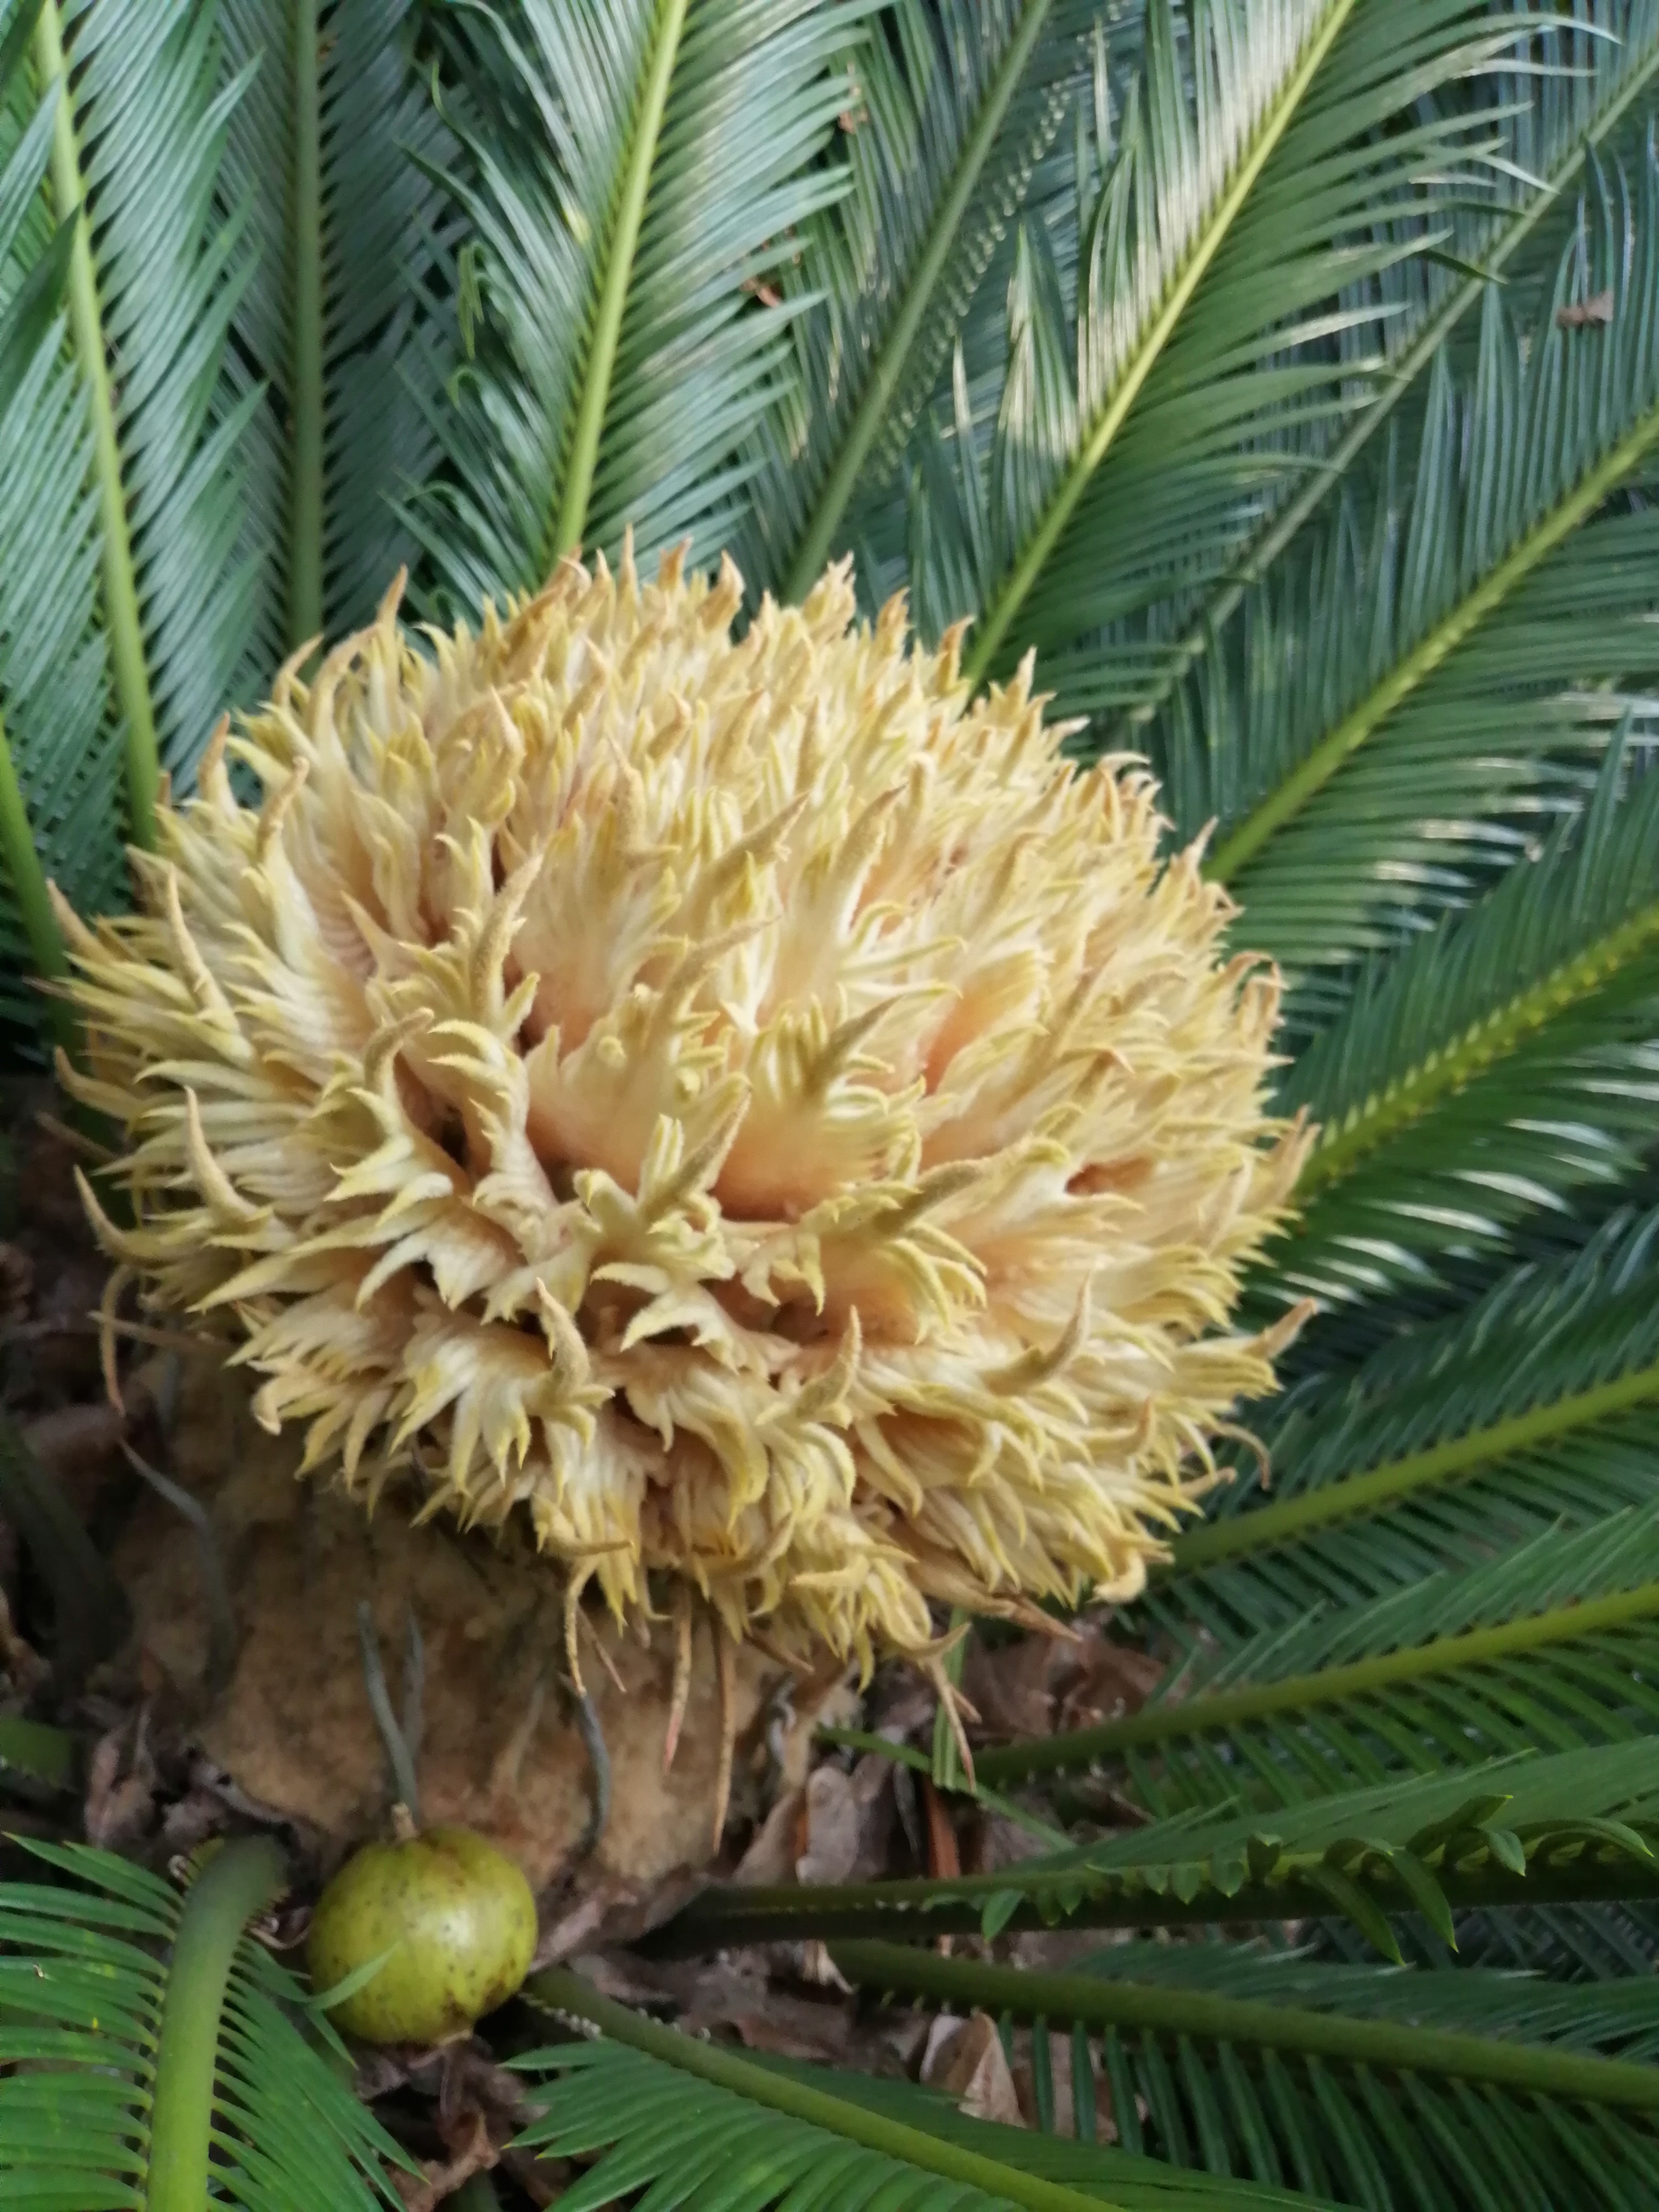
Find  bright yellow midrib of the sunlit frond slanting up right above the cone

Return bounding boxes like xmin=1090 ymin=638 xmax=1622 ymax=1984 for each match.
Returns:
xmin=962 ymin=0 xmax=1356 ymax=688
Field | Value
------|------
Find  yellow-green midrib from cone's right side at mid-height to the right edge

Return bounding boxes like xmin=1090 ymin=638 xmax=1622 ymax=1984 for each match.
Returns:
xmin=1296 ymin=880 xmax=1659 ymax=1203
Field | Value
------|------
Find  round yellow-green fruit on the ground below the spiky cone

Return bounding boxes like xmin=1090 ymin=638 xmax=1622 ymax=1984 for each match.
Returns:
xmin=307 ymin=1827 xmax=535 ymax=2044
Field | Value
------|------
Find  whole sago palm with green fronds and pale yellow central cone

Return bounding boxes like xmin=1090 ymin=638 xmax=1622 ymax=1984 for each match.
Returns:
xmin=0 ymin=0 xmax=1659 ymax=2212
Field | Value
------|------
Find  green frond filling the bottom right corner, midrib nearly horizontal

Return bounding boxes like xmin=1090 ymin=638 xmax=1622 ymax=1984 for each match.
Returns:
xmin=832 ymin=1942 xmax=1659 ymax=2212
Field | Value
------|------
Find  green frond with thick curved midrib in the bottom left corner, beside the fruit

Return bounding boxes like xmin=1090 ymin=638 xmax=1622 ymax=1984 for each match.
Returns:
xmin=0 ymin=1840 xmax=407 ymax=2212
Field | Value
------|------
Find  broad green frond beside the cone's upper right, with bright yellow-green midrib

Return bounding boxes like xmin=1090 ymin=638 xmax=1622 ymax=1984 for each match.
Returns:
xmin=1161 ymin=125 xmax=1659 ymax=973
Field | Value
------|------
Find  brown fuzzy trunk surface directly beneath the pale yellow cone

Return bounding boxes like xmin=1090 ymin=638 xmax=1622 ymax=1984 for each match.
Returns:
xmin=117 ymin=1358 xmax=841 ymax=1896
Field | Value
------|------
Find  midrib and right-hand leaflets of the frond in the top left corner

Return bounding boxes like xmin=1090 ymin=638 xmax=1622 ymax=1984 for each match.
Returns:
xmin=29 ymin=0 xmax=252 ymax=814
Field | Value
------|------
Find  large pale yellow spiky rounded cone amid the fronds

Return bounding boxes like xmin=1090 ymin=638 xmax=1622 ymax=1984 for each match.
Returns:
xmin=61 ymin=557 xmax=1303 ymax=1665
